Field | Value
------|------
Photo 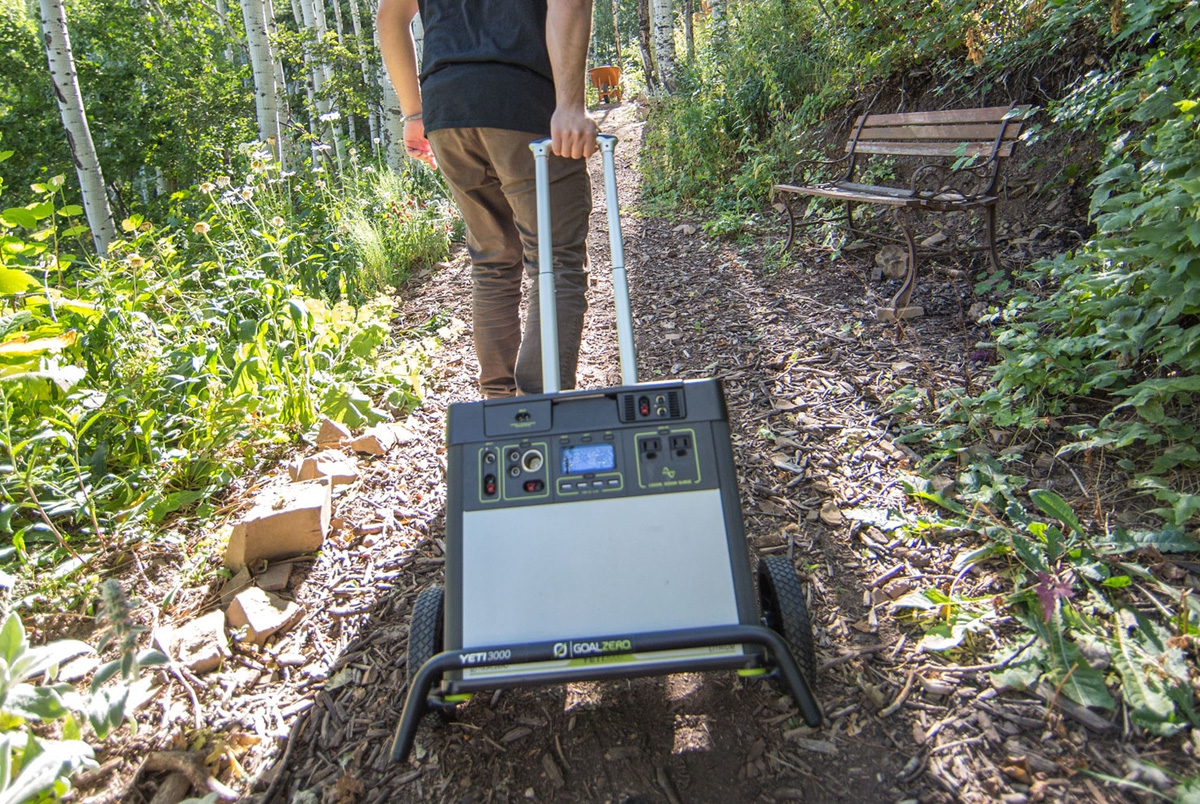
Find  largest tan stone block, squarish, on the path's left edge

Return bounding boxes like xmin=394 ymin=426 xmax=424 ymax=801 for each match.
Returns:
xmin=224 ymin=480 xmax=331 ymax=570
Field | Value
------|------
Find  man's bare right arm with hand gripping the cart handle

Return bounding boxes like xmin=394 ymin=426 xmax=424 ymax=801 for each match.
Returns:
xmin=547 ymin=0 xmax=599 ymax=160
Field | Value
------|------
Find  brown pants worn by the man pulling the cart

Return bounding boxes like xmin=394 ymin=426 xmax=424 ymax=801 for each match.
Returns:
xmin=428 ymin=128 xmax=592 ymax=398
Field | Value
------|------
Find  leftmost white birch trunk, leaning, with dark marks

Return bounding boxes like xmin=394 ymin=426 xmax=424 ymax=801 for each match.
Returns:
xmin=41 ymin=0 xmax=116 ymax=257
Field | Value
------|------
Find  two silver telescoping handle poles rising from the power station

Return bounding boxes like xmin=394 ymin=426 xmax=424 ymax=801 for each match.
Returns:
xmin=529 ymin=134 xmax=637 ymax=394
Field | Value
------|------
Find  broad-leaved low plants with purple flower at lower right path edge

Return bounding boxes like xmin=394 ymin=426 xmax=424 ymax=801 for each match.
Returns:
xmin=895 ymin=460 xmax=1200 ymax=736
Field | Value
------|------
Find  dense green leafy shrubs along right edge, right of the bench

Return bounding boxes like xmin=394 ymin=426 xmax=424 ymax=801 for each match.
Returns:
xmin=902 ymin=0 xmax=1200 ymax=513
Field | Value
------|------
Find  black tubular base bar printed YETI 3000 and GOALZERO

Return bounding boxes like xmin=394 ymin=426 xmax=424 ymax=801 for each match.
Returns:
xmin=391 ymin=625 xmax=822 ymax=762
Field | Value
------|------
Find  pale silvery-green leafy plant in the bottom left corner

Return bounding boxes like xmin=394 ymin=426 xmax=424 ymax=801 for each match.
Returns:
xmin=0 ymin=582 xmax=167 ymax=804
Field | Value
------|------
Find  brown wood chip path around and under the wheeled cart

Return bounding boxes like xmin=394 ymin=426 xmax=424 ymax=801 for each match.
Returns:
xmin=70 ymin=104 xmax=1194 ymax=804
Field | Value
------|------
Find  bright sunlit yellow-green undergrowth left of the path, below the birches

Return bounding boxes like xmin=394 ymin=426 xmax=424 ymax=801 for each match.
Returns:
xmin=0 ymin=144 xmax=454 ymax=586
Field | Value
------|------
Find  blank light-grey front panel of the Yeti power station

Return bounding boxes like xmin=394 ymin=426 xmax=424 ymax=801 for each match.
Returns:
xmin=462 ymin=488 xmax=738 ymax=648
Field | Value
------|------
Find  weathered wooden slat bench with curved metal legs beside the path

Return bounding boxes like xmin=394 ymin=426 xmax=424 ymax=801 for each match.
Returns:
xmin=772 ymin=106 xmax=1030 ymax=320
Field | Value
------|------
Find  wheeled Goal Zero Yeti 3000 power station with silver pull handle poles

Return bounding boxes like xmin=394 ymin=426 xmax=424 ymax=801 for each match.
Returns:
xmin=391 ymin=134 xmax=822 ymax=761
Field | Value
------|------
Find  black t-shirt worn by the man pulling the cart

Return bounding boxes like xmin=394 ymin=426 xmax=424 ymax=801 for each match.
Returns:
xmin=419 ymin=0 xmax=554 ymax=134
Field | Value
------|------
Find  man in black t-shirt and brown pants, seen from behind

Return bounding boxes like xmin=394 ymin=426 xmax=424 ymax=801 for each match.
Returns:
xmin=377 ymin=0 xmax=598 ymax=398
